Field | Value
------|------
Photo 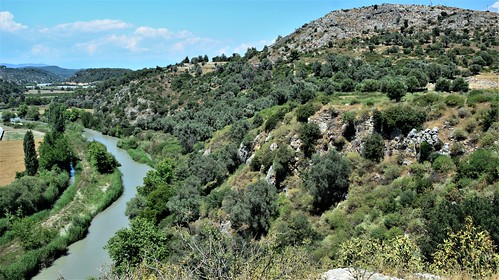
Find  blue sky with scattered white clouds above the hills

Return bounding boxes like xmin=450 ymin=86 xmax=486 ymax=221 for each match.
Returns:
xmin=0 ymin=0 xmax=499 ymax=69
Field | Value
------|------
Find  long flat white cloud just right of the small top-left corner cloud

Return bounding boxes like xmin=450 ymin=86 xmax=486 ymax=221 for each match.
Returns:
xmin=53 ymin=19 xmax=131 ymax=33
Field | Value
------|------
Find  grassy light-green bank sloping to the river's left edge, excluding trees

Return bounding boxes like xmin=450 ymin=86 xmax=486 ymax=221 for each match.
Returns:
xmin=0 ymin=124 xmax=123 ymax=279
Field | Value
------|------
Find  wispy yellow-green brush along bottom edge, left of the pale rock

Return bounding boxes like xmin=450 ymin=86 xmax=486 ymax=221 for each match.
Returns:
xmin=103 ymin=227 xmax=320 ymax=280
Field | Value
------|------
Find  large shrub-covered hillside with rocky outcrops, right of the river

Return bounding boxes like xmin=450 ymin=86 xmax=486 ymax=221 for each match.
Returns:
xmin=60 ymin=5 xmax=499 ymax=279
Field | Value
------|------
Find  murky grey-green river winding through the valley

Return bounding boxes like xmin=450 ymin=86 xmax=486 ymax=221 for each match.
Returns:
xmin=33 ymin=129 xmax=151 ymax=279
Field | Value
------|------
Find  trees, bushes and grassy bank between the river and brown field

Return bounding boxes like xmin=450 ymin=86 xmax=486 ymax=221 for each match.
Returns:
xmin=0 ymin=103 xmax=123 ymax=279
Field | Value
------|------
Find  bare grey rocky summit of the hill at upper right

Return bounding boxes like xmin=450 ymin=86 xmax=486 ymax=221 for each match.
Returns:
xmin=273 ymin=4 xmax=499 ymax=51
